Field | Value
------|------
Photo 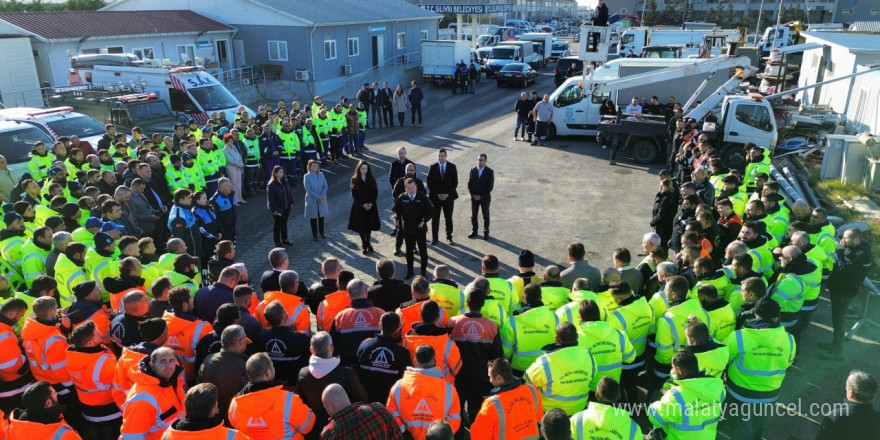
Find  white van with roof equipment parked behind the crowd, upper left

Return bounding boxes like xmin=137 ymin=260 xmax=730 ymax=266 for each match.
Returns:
xmin=69 ymin=54 xmax=249 ymax=124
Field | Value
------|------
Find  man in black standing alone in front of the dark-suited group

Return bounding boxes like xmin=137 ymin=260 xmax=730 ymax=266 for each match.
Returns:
xmin=391 ymin=179 xmax=434 ymax=279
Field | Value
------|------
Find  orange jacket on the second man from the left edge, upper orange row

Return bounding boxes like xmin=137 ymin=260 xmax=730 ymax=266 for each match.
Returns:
xmin=21 ymin=318 xmax=73 ymax=387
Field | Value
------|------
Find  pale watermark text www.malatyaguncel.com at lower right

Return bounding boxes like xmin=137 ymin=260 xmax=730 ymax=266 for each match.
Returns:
xmin=616 ymin=399 xmax=849 ymax=420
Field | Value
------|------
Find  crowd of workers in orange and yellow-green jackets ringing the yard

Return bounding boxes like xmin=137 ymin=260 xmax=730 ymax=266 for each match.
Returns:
xmin=0 ymin=86 xmax=878 ymax=440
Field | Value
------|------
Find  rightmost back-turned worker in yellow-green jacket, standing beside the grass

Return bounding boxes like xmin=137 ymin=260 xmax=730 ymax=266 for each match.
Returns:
xmin=721 ymin=295 xmax=797 ymax=439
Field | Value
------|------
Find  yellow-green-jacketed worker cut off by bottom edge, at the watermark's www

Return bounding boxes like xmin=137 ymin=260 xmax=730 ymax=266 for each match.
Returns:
xmin=571 ymin=376 xmax=642 ymax=440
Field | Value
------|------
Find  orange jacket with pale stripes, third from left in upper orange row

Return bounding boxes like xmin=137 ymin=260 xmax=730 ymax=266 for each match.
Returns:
xmin=67 ymin=346 xmax=122 ymax=423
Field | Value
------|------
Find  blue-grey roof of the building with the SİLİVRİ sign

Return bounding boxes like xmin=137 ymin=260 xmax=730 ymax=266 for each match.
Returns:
xmin=253 ymin=0 xmax=440 ymax=25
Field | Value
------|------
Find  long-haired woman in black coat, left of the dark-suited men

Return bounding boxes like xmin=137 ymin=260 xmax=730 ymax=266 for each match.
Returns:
xmin=348 ymin=160 xmax=379 ymax=255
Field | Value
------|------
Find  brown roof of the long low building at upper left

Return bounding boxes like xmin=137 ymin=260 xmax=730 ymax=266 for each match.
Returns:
xmin=0 ymin=10 xmax=235 ymax=40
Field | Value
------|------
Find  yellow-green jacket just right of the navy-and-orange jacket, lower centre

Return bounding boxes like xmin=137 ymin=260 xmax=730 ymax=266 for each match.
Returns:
xmin=501 ymin=305 xmax=559 ymax=371
